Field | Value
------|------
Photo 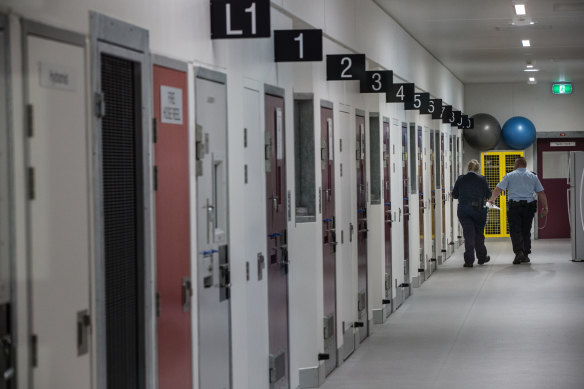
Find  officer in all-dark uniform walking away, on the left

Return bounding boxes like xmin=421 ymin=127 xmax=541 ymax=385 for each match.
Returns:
xmin=452 ymin=159 xmax=491 ymax=267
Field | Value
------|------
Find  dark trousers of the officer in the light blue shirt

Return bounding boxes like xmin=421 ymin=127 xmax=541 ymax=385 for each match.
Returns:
xmin=507 ymin=201 xmax=537 ymax=255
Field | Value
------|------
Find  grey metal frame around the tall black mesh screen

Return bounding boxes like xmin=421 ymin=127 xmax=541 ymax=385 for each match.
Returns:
xmin=89 ymin=11 xmax=153 ymax=389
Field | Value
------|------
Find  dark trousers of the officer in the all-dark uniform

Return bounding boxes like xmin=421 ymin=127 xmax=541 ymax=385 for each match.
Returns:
xmin=457 ymin=204 xmax=487 ymax=264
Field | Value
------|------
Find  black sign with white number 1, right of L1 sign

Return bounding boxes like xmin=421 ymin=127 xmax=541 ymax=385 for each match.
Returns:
xmin=274 ymin=30 xmax=322 ymax=62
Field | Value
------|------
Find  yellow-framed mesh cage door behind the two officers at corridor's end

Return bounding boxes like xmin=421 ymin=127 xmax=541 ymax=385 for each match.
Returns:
xmin=481 ymin=151 xmax=523 ymax=238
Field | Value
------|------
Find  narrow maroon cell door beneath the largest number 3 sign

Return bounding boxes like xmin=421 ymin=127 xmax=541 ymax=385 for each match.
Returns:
xmin=356 ymin=115 xmax=369 ymax=341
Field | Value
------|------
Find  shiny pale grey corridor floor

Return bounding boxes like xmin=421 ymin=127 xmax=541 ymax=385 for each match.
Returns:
xmin=321 ymin=240 xmax=584 ymax=389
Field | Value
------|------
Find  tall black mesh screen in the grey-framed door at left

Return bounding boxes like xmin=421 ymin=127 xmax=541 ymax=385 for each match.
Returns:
xmin=101 ymin=54 xmax=143 ymax=389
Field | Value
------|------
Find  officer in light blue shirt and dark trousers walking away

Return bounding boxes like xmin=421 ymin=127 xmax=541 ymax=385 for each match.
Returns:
xmin=489 ymin=157 xmax=548 ymax=265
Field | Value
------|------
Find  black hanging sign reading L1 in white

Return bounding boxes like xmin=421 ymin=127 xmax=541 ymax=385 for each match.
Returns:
xmin=211 ymin=0 xmax=270 ymax=39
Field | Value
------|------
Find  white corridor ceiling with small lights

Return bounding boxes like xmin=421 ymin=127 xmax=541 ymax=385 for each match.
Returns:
xmin=374 ymin=0 xmax=584 ymax=84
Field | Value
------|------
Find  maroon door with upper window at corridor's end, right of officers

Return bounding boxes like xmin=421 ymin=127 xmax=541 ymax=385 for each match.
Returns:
xmin=537 ymin=138 xmax=584 ymax=239
